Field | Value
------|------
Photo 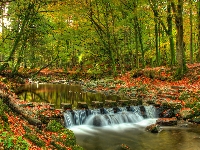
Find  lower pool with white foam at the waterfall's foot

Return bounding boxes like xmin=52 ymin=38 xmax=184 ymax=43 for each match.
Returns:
xmin=69 ymin=118 xmax=200 ymax=150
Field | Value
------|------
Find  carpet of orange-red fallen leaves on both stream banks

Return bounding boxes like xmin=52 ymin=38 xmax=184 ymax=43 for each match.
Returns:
xmin=0 ymin=64 xmax=200 ymax=150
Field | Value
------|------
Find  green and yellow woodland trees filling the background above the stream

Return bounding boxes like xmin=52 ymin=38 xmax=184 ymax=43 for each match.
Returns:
xmin=0 ymin=0 xmax=200 ymax=77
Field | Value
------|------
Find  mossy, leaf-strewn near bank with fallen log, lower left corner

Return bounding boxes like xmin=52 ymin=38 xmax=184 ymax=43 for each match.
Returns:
xmin=0 ymin=83 xmax=83 ymax=150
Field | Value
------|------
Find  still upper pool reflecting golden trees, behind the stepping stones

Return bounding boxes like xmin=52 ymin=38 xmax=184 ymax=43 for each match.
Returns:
xmin=17 ymin=84 xmax=120 ymax=108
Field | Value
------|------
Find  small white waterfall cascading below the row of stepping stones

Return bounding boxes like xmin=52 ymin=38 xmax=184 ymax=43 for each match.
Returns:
xmin=64 ymin=106 xmax=157 ymax=127
